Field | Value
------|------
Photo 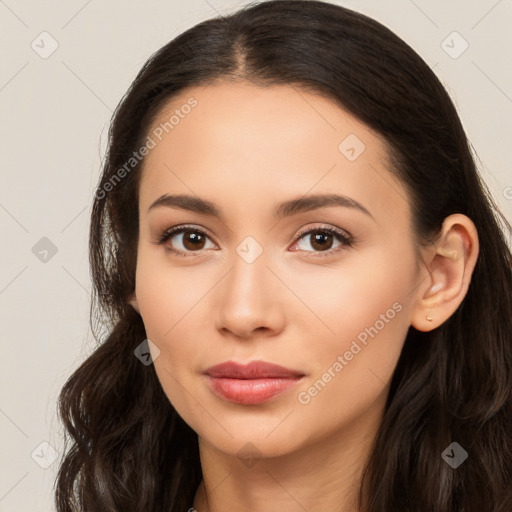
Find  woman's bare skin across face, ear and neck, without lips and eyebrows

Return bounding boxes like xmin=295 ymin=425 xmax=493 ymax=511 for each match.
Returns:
xmin=130 ymin=82 xmax=478 ymax=512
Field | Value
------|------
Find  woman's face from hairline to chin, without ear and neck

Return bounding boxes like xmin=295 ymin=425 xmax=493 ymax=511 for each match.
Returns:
xmin=132 ymin=83 xmax=419 ymax=456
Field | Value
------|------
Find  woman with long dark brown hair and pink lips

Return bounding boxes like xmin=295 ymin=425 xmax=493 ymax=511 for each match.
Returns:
xmin=56 ymin=1 xmax=512 ymax=512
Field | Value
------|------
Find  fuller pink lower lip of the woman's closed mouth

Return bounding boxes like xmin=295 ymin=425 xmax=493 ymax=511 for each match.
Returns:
xmin=207 ymin=375 xmax=302 ymax=405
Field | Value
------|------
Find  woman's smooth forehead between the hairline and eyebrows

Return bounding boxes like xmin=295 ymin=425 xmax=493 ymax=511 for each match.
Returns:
xmin=136 ymin=83 xmax=406 ymax=220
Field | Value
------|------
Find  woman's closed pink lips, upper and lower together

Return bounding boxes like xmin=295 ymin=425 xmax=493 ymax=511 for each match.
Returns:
xmin=205 ymin=361 xmax=304 ymax=405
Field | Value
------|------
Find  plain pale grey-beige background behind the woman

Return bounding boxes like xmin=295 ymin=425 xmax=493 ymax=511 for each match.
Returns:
xmin=0 ymin=0 xmax=512 ymax=512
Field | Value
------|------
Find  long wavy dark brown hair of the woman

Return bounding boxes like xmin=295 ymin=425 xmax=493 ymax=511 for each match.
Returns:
xmin=55 ymin=0 xmax=512 ymax=512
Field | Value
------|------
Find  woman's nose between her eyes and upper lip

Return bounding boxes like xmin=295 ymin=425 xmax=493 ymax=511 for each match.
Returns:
xmin=215 ymin=254 xmax=285 ymax=339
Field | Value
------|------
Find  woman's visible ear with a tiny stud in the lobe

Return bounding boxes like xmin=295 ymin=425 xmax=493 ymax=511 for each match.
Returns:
xmin=411 ymin=213 xmax=479 ymax=332
